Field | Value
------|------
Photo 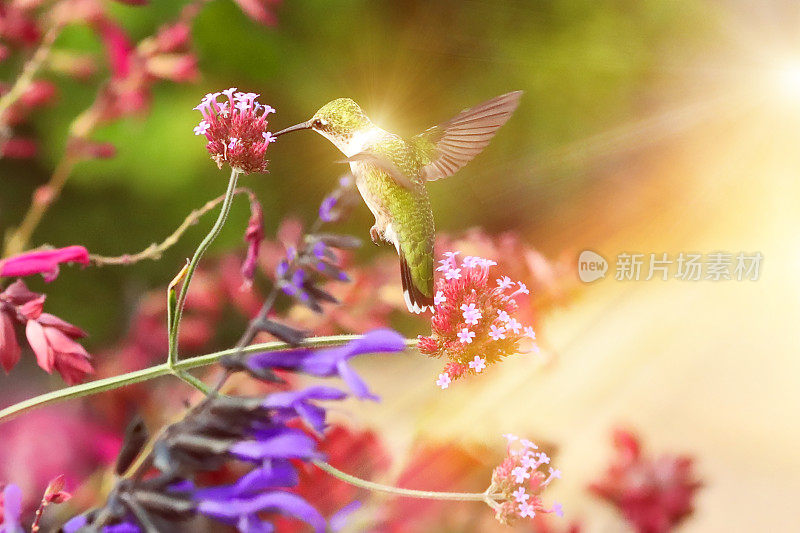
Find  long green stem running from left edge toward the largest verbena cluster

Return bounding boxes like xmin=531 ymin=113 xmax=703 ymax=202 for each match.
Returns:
xmin=0 ymin=335 xmax=417 ymax=424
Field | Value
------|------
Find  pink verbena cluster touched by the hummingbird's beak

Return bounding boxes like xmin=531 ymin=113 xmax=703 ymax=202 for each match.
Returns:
xmin=194 ymin=87 xmax=275 ymax=174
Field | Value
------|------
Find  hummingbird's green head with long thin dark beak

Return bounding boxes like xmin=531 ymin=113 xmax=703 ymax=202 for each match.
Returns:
xmin=275 ymin=98 xmax=372 ymax=156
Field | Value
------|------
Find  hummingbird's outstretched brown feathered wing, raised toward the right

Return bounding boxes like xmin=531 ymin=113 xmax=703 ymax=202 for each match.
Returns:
xmin=415 ymin=91 xmax=522 ymax=181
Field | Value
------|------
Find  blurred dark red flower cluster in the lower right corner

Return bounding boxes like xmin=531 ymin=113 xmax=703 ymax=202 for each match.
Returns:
xmin=590 ymin=430 xmax=701 ymax=533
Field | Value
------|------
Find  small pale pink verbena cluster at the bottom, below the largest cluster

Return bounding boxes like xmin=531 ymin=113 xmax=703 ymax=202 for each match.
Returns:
xmin=488 ymin=434 xmax=563 ymax=524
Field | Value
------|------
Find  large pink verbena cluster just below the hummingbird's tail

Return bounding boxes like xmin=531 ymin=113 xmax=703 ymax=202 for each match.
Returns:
xmin=418 ymin=252 xmax=536 ymax=389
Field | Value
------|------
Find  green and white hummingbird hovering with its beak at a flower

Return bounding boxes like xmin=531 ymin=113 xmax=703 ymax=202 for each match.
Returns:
xmin=274 ymin=91 xmax=522 ymax=313
